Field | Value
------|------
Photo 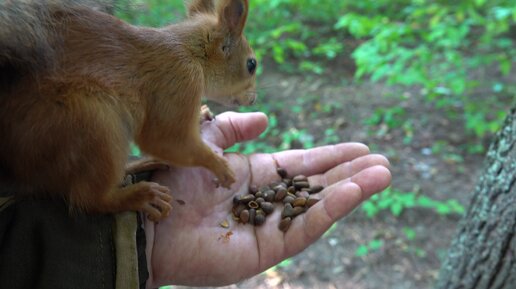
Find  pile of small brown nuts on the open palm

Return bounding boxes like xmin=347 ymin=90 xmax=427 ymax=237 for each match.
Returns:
xmin=231 ymin=168 xmax=323 ymax=232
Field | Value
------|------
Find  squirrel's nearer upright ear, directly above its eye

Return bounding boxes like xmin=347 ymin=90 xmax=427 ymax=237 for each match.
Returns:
xmin=217 ymin=0 xmax=249 ymax=37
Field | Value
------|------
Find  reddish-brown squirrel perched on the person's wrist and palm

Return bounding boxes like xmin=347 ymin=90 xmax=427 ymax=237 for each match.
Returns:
xmin=0 ymin=0 xmax=257 ymax=221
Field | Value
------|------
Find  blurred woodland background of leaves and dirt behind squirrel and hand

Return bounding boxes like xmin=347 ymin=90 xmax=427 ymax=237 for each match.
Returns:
xmin=115 ymin=0 xmax=516 ymax=289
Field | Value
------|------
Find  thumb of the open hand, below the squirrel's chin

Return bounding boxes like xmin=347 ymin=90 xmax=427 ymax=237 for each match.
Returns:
xmin=201 ymin=112 xmax=268 ymax=149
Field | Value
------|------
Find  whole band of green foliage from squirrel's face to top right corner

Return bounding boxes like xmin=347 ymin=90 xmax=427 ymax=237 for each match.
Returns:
xmin=248 ymin=0 xmax=516 ymax=143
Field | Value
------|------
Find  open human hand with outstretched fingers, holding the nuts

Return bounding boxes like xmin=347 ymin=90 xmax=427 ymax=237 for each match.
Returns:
xmin=145 ymin=112 xmax=391 ymax=288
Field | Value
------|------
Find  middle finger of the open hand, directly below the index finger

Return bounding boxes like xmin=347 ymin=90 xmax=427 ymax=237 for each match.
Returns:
xmin=308 ymin=154 xmax=390 ymax=187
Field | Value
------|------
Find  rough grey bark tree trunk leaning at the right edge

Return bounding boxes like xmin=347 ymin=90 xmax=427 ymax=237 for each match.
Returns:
xmin=436 ymin=108 xmax=516 ymax=289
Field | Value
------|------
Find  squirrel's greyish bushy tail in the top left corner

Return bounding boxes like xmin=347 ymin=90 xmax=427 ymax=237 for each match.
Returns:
xmin=0 ymin=0 xmax=113 ymax=89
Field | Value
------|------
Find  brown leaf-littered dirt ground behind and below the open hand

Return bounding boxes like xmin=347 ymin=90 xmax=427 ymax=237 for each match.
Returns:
xmin=173 ymin=62 xmax=500 ymax=289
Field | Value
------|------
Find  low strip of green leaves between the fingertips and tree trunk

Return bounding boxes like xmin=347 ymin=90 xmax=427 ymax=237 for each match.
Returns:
xmin=361 ymin=187 xmax=465 ymax=218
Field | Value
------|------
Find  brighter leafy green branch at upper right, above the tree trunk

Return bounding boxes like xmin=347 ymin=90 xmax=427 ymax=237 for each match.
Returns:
xmin=335 ymin=0 xmax=516 ymax=137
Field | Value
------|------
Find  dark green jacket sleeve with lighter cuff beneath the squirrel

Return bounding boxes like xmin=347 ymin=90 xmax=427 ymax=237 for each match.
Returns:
xmin=0 ymin=196 xmax=148 ymax=289
